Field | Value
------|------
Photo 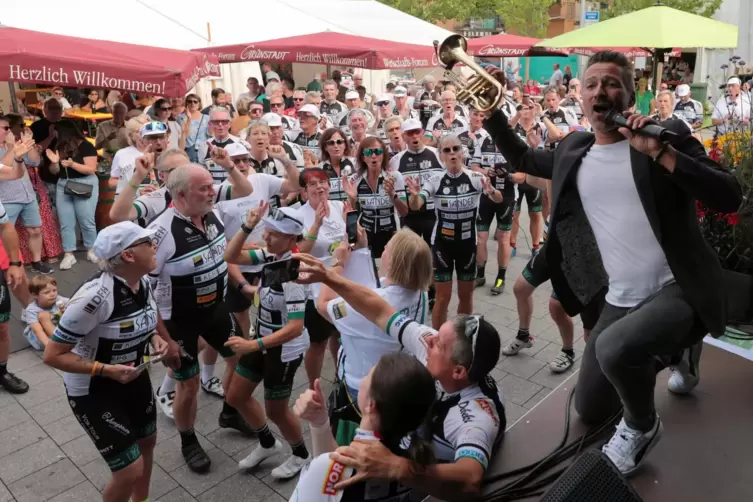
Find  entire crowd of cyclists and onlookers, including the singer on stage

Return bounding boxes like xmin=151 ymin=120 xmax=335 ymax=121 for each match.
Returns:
xmin=0 ymin=51 xmax=742 ymax=502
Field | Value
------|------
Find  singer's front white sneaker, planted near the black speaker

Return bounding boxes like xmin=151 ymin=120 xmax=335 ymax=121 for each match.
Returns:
xmin=601 ymin=415 xmax=664 ymax=476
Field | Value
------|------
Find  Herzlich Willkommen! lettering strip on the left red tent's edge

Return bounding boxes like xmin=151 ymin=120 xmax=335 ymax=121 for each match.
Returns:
xmin=10 ymin=64 xmax=165 ymax=94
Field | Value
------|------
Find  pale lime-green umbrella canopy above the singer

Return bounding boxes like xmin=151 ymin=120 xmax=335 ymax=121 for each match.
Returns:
xmin=536 ymin=6 xmax=737 ymax=49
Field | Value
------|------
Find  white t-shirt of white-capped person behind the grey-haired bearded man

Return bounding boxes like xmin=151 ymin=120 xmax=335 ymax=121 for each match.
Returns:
xmin=214 ymin=173 xmax=285 ymax=272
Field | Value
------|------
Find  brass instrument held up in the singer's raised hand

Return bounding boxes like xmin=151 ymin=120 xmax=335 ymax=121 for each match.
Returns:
xmin=434 ymin=35 xmax=507 ymax=112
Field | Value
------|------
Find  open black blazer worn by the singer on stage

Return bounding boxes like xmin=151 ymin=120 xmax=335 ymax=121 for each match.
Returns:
xmin=484 ymin=111 xmax=742 ymax=336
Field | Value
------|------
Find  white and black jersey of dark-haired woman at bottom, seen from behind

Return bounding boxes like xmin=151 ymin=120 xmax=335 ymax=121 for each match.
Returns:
xmin=290 ymin=429 xmax=412 ymax=502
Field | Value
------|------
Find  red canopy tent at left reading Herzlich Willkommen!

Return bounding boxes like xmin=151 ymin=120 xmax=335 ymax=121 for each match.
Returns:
xmin=0 ymin=26 xmax=220 ymax=97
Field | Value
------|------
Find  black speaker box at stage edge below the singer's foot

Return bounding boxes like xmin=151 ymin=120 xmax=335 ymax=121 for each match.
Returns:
xmin=541 ymin=450 xmax=642 ymax=502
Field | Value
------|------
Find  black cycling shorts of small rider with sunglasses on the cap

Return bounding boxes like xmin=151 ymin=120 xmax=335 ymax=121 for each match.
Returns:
xmin=235 ymin=346 xmax=303 ymax=401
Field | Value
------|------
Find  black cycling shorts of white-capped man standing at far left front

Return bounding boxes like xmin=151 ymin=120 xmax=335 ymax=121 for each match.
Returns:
xmin=68 ymin=371 xmax=157 ymax=472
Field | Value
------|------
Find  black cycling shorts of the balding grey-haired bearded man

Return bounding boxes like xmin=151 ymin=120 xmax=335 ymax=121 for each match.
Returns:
xmin=164 ymin=303 xmax=242 ymax=381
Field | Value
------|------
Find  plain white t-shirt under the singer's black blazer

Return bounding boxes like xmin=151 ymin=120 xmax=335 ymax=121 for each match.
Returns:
xmin=577 ymin=140 xmax=674 ymax=308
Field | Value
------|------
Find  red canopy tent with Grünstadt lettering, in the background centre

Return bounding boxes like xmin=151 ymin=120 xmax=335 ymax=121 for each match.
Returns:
xmin=193 ymin=31 xmax=437 ymax=70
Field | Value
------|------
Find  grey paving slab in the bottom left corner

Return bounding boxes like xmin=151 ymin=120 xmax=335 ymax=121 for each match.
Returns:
xmin=8 ymin=458 xmax=86 ymax=502
